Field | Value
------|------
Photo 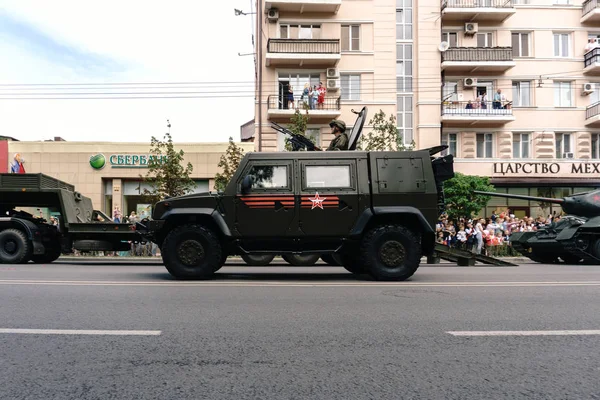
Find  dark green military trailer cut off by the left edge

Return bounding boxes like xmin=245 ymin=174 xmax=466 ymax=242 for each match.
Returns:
xmin=0 ymin=174 xmax=141 ymax=264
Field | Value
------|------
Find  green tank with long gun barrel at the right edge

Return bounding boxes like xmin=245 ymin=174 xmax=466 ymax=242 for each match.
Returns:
xmin=475 ymin=190 xmax=600 ymax=264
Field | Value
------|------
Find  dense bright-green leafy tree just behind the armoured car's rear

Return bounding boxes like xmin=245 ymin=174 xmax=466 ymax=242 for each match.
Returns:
xmin=444 ymin=172 xmax=494 ymax=221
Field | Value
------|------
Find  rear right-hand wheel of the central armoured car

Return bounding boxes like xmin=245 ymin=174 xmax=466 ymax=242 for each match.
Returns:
xmin=360 ymin=225 xmax=421 ymax=281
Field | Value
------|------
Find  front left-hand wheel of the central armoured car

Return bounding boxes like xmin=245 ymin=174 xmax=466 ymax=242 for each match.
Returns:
xmin=162 ymin=224 xmax=223 ymax=279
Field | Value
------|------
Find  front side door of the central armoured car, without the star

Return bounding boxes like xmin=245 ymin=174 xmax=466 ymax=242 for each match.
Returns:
xmin=234 ymin=160 xmax=296 ymax=244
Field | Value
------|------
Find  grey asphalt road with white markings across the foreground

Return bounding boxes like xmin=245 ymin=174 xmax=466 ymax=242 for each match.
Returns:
xmin=0 ymin=262 xmax=600 ymax=400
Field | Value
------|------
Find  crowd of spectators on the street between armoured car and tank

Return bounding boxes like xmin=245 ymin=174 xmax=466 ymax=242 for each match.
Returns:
xmin=436 ymin=212 xmax=560 ymax=256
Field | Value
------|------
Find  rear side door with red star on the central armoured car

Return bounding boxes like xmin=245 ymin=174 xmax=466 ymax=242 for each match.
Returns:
xmin=298 ymin=159 xmax=361 ymax=238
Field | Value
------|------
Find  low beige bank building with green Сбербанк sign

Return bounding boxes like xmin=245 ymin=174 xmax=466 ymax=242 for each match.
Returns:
xmin=0 ymin=141 xmax=254 ymax=216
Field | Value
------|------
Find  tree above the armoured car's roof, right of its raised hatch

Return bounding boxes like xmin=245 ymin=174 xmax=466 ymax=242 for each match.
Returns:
xmin=359 ymin=109 xmax=415 ymax=151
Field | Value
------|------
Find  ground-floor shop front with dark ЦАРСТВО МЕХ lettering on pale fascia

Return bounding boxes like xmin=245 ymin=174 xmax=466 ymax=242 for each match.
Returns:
xmin=455 ymin=159 xmax=600 ymax=218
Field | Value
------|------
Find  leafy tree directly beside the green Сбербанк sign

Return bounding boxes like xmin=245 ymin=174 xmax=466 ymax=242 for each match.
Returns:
xmin=143 ymin=130 xmax=196 ymax=203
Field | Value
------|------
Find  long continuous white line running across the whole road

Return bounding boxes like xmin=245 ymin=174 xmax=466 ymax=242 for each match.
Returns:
xmin=0 ymin=279 xmax=600 ymax=287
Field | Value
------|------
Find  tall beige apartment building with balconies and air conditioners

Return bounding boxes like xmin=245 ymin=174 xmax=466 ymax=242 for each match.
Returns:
xmin=255 ymin=0 xmax=600 ymax=217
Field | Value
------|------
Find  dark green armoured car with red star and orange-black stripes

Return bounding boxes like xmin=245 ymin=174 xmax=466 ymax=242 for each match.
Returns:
xmin=137 ymin=108 xmax=454 ymax=280
